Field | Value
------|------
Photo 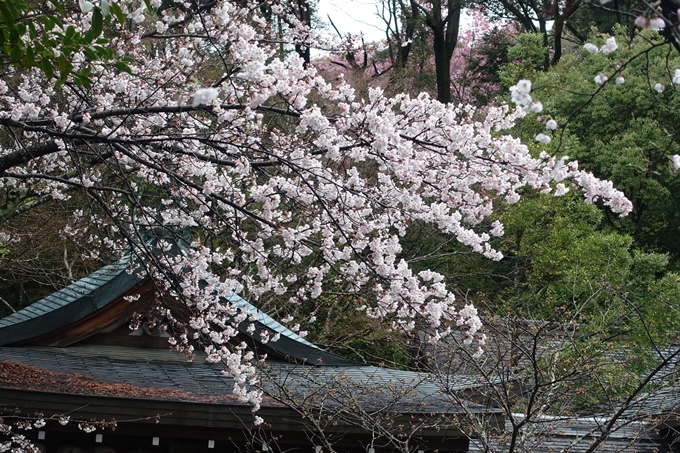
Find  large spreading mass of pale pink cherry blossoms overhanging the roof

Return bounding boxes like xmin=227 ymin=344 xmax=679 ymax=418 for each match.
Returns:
xmin=0 ymin=0 xmax=631 ymax=409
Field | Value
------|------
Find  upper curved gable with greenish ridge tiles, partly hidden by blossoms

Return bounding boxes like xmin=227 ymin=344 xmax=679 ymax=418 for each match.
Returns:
xmin=0 ymin=247 xmax=355 ymax=365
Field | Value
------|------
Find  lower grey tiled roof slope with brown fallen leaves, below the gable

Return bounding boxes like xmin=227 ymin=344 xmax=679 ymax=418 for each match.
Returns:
xmin=0 ymin=345 xmax=486 ymax=414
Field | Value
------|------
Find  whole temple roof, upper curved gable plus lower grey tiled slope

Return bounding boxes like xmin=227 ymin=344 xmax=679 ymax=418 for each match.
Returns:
xmin=0 ymin=242 xmax=498 ymax=430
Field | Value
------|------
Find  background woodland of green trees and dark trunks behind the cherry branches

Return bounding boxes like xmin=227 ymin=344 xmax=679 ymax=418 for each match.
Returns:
xmin=262 ymin=1 xmax=680 ymax=366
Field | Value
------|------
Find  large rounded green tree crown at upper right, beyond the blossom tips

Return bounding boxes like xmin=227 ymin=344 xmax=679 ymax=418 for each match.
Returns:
xmin=522 ymin=27 xmax=680 ymax=266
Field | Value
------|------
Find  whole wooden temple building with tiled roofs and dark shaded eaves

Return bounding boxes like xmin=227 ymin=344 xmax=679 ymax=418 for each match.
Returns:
xmin=0 ymin=251 xmax=494 ymax=453
